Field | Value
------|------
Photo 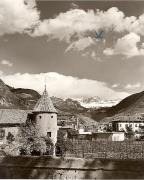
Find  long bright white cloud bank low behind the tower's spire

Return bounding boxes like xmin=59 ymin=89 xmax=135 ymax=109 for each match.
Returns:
xmin=1 ymin=72 xmax=129 ymax=99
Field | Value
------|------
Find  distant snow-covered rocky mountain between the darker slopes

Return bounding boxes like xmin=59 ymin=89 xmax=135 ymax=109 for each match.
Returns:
xmin=75 ymin=96 xmax=121 ymax=109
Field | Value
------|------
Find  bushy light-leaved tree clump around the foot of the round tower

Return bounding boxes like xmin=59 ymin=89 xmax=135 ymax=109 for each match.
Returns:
xmin=1 ymin=122 xmax=53 ymax=156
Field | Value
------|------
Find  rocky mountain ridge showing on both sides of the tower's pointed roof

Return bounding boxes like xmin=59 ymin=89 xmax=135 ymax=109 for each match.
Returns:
xmin=0 ymin=80 xmax=95 ymax=125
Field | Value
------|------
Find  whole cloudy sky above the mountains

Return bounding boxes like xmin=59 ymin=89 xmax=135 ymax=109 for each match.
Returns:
xmin=0 ymin=0 xmax=144 ymax=99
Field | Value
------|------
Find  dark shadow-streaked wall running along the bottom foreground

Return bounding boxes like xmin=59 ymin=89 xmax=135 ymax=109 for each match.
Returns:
xmin=0 ymin=156 xmax=144 ymax=179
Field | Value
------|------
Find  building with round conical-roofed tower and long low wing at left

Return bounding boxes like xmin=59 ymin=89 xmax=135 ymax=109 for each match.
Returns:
xmin=0 ymin=88 xmax=58 ymax=153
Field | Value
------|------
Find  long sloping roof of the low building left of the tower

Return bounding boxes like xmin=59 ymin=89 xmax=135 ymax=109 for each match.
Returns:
xmin=0 ymin=109 xmax=31 ymax=124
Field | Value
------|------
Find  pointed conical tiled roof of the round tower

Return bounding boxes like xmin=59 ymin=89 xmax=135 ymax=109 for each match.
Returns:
xmin=33 ymin=88 xmax=57 ymax=113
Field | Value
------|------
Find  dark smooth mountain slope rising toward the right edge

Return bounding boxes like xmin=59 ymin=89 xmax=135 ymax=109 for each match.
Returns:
xmin=91 ymin=91 xmax=144 ymax=121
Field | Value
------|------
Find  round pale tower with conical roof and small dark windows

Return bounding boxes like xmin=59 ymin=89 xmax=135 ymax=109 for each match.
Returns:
xmin=33 ymin=86 xmax=58 ymax=155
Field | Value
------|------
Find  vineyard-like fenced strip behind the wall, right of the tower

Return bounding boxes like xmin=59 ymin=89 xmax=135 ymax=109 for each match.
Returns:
xmin=65 ymin=140 xmax=144 ymax=159
